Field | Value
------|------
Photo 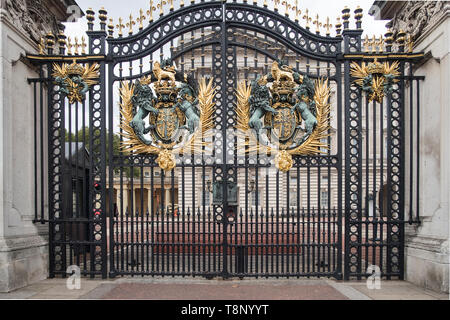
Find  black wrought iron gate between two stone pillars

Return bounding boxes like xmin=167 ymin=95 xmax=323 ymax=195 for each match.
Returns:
xmin=28 ymin=1 xmax=422 ymax=279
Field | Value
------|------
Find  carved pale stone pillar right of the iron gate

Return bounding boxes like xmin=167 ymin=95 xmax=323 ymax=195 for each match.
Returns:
xmin=373 ymin=1 xmax=450 ymax=292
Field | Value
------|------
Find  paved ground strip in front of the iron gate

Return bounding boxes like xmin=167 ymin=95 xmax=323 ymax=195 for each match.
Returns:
xmin=0 ymin=278 xmax=449 ymax=300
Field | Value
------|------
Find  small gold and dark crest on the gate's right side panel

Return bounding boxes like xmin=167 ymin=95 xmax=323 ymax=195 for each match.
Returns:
xmin=350 ymin=59 xmax=400 ymax=103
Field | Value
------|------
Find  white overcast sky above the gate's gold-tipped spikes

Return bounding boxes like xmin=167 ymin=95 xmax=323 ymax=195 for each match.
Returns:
xmin=66 ymin=0 xmax=387 ymax=37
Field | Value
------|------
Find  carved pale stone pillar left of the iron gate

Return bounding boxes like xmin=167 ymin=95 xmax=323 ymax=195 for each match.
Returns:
xmin=0 ymin=0 xmax=80 ymax=292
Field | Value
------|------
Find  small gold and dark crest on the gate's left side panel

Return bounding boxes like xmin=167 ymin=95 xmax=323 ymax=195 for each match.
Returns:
xmin=53 ymin=61 xmax=100 ymax=104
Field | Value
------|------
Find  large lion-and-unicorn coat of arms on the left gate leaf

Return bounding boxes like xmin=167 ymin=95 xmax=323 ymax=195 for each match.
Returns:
xmin=120 ymin=59 xmax=216 ymax=171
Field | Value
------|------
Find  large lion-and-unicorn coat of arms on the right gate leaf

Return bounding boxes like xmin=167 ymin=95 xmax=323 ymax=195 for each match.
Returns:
xmin=236 ymin=61 xmax=330 ymax=172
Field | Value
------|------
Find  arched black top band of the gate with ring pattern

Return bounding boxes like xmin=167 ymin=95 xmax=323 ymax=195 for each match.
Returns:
xmin=108 ymin=1 xmax=342 ymax=62
